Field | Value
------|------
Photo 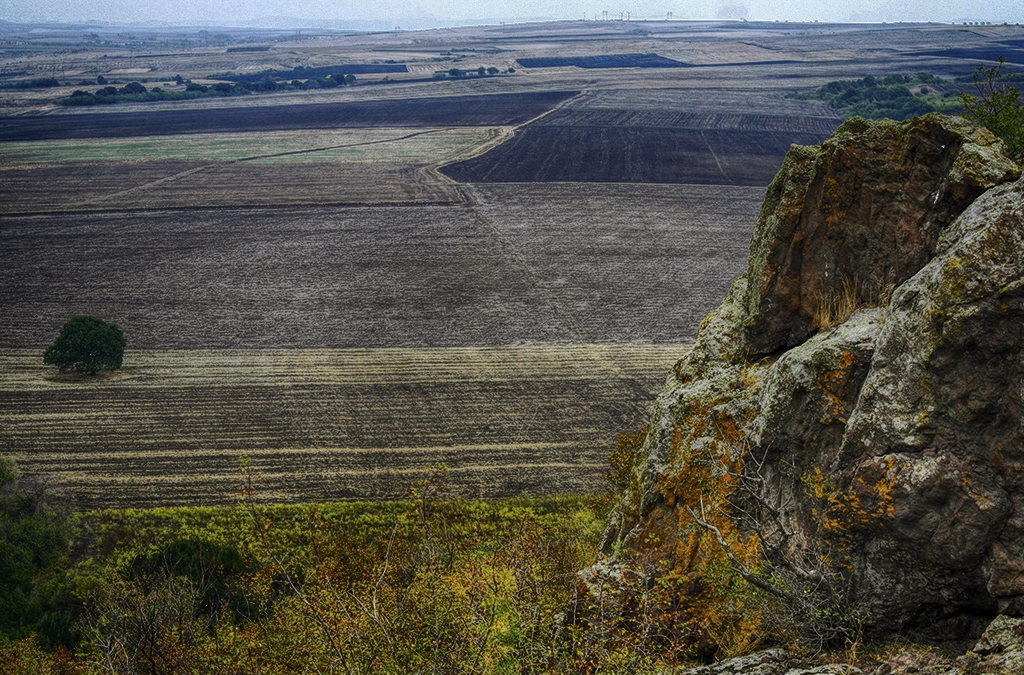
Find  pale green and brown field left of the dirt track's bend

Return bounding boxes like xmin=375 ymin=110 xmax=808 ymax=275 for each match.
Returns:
xmin=0 ymin=127 xmax=500 ymax=213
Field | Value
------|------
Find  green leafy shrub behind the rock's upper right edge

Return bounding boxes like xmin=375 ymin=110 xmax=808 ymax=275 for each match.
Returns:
xmin=961 ymin=56 xmax=1024 ymax=159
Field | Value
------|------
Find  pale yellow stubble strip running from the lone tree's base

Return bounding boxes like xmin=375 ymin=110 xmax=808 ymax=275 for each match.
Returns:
xmin=0 ymin=343 xmax=690 ymax=391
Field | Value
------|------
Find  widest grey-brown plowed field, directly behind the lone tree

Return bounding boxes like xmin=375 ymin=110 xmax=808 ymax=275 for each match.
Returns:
xmin=0 ymin=184 xmax=763 ymax=348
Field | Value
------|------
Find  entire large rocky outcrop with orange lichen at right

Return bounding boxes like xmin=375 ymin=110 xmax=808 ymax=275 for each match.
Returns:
xmin=602 ymin=116 xmax=1024 ymax=633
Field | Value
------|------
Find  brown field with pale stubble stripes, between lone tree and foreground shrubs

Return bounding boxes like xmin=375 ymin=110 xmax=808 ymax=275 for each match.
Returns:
xmin=0 ymin=345 xmax=686 ymax=508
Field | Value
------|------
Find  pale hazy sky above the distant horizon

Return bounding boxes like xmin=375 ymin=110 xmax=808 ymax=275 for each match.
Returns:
xmin=0 ymin=0 xmax=1024 ymax=26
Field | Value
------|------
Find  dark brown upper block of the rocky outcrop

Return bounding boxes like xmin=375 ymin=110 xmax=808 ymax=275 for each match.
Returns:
xmin=743 ymin=117 xmax=1015 ymax=357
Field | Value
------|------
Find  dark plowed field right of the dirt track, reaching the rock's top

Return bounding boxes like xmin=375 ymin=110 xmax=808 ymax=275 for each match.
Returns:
xmin=441 ymin=90 xmax=840 ymax=186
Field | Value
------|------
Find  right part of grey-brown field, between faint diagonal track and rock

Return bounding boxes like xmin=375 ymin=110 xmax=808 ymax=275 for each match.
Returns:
xmin=464 ymin=184 xmax=763 ymax=342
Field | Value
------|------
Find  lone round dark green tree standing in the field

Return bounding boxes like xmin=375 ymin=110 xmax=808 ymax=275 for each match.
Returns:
xmin=43 ymin=315 xmax=125 ymax=375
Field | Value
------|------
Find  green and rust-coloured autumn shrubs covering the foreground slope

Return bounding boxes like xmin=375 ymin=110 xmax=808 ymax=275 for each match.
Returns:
xmin=0 ymin=432 xmax=790 ymax=675
